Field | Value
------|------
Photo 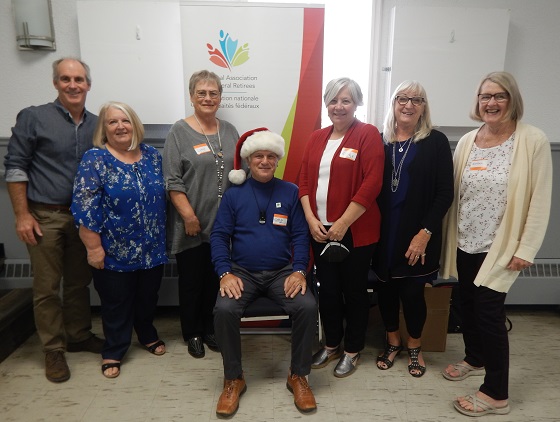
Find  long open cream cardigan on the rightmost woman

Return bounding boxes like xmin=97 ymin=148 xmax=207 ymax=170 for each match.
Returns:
xmin=441 ymin=122 xmax=552 ymax=293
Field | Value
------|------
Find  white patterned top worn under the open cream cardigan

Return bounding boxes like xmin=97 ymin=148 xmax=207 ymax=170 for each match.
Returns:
xmin=458 ymin=134 xmax=515 ymax=254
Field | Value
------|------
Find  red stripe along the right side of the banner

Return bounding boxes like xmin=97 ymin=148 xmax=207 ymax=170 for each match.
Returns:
xmin=282 ymin=8 xmax=325 ymax=182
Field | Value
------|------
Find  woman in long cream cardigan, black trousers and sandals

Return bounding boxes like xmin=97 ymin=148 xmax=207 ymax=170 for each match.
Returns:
xmin=442 ymin=72 xmax=552 ymax=416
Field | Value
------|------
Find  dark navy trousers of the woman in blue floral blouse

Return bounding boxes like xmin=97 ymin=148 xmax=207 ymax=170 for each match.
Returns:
xmin=93 ymin=265 xmax=163 ymax=361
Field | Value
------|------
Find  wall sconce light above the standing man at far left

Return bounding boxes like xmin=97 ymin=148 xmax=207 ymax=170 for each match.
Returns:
xmin=12 ymin=0 xmax=56 ymax=50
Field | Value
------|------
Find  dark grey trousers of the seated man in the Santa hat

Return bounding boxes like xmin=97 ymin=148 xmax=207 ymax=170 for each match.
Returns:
xmin=214 ymin=265 xmax=317 ymax=380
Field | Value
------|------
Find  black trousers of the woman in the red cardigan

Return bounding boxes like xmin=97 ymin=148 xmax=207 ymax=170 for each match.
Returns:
xmin=311 ymin=234 xmax=375 ymax=353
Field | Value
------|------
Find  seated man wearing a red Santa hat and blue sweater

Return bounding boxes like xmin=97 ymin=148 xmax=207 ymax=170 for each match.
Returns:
xmin=210 ymin=128 xmax=317 ymax=417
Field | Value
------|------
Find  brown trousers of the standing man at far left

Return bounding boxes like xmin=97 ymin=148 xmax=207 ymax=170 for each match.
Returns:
xmin=27 ymin=204 xmax=92 ymax=353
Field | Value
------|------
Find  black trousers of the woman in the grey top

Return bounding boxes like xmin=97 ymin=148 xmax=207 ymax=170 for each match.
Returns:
xmin=175 ymin=243 xmax=220 ymax=341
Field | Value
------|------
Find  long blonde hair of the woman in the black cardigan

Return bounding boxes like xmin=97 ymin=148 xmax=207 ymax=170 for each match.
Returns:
xmin=383 ymin=80 xmax=433 ymax=143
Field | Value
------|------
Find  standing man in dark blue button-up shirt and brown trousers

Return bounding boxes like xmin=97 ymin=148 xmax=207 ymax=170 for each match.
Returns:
xmin=4 ymin=58 xmax=103 ymax=382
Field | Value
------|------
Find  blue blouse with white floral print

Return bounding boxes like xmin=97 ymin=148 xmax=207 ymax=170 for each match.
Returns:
xmin=71 ymin=144 xmax=167 ymax=271
